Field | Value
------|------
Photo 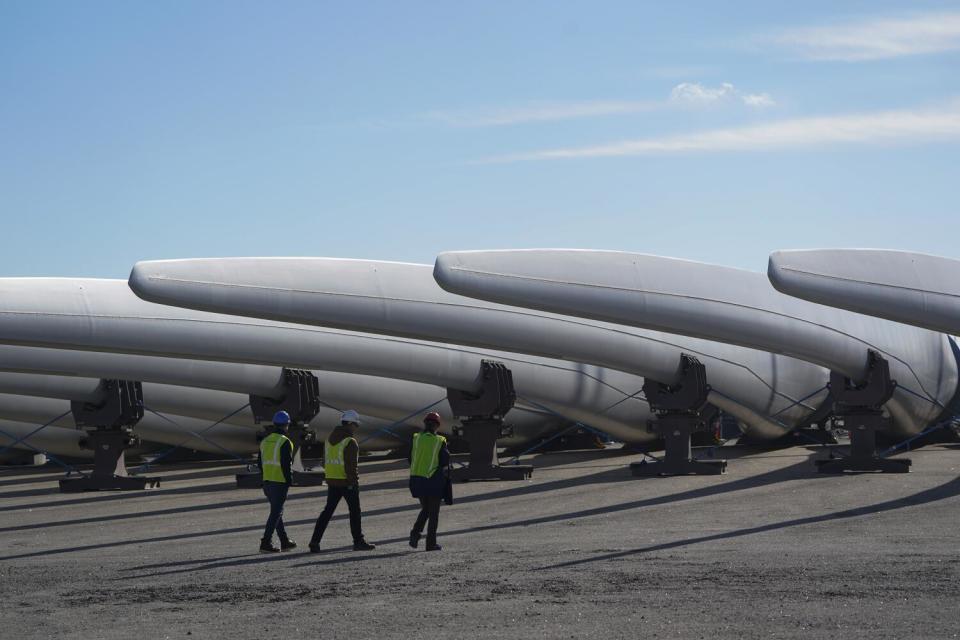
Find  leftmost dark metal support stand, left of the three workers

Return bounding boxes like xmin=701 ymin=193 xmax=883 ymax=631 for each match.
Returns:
xmin=60 ymin=380 xmax=160 ymax=493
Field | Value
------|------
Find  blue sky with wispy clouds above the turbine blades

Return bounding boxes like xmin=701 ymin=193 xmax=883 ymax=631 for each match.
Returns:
xmin=0 ymin=0 xmax=960 ymax=277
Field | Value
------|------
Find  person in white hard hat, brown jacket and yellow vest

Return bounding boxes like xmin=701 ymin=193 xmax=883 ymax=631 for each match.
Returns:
xmin=310 ymin=409 xmax=376 ymax=553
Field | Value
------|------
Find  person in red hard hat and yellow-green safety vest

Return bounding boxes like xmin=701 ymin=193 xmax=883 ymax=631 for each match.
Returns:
xmin=410 ymin=411 xmax=453 ymax=551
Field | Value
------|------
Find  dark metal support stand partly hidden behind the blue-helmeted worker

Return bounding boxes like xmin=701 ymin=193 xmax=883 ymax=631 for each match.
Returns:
xmin=237 ymin=369 xmax=323 ymax=489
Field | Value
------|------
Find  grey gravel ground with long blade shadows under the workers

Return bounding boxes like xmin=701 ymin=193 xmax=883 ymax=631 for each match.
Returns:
xmin=0 ymin=445 xmax=960 ymax=640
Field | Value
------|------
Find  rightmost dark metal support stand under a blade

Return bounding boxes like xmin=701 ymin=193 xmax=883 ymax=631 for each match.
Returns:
xmin=816 ymin=349 xmax=911 ymax=473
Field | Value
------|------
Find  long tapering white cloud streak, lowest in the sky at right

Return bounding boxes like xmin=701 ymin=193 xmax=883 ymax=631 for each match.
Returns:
xmin=481 ymin=101 xmax=960 ymax=163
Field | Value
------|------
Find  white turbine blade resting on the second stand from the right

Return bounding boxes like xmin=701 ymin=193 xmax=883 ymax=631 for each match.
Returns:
xmin=130 ymin=258 xmax=828 ymax=437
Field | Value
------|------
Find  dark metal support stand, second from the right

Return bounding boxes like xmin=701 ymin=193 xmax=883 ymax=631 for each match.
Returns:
xmin=630 ymin=354 xmax=727 ymax=477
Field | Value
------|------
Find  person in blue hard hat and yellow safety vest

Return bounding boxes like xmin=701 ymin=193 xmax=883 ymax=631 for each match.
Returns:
xmin=260 ymin=411 xmax=297 ymax=553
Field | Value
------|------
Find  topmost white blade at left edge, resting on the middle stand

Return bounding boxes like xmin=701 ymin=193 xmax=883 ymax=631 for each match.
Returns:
xmin=0 ymin=278 xmax=650 ymax=441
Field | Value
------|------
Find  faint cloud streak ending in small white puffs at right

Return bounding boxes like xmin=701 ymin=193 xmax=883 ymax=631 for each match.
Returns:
xmin=426 ymin=82 xmax=776 ymax=127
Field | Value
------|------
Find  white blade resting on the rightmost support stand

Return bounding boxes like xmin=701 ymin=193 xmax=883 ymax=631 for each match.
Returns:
xmin=435 ymin=249 xmax=957 ymax=433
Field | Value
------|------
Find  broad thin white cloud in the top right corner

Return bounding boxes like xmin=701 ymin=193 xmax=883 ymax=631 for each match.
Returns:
xmin=772 ymin=12 xmax=960 ymax=62
